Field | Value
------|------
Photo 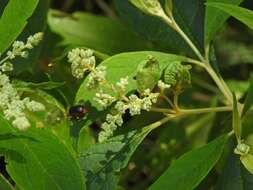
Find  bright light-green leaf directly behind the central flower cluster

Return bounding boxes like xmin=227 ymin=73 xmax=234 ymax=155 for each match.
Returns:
xmin=76 ymin=51 xmax=186 ymax=110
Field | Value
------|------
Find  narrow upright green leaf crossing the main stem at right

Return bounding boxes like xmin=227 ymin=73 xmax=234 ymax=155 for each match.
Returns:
xmin=233 ymin=93 xmax=242 ymax=141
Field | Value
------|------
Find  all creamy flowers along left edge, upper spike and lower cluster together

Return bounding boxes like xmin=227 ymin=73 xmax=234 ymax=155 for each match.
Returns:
xmin=0 ymin=33 xmax=45 ymax=130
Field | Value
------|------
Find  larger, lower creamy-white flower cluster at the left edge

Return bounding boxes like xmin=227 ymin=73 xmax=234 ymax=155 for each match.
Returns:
xmin=0 ymin=72 xmax=45 ymax=130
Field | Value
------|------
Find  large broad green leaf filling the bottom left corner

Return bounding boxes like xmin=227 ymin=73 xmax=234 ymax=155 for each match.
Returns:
xmin=0 ymin=116 xmax=85 ymax=190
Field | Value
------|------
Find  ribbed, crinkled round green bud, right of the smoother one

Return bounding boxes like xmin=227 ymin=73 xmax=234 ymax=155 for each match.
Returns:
xmin=164 ymin=62 xmax=191 ymax=93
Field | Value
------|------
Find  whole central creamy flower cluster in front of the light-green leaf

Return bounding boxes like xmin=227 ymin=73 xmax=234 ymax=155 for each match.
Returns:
xmin=68 ymin=48 xmax=162 ymax=142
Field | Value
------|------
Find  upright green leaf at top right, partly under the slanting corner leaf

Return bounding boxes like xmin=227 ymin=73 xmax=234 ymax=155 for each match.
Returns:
xmin=205 ymin=0 xmax=243 ymax=46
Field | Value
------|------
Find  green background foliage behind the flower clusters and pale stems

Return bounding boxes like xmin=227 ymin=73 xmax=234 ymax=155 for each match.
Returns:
xmin=0 ymin=0 xmax=253 ymax=190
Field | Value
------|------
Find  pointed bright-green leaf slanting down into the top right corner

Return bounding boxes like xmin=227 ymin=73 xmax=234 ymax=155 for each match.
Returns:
xmin=207 ymin=3 xmax=253 ymax=29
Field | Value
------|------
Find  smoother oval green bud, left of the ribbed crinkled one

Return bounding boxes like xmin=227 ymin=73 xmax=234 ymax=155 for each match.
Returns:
xmin=136 ymin=56 xmax=161 ymax=93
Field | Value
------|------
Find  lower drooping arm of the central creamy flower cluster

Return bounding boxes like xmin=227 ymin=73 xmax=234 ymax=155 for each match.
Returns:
xmin=98 ymin=78 xmax=159 ymax=142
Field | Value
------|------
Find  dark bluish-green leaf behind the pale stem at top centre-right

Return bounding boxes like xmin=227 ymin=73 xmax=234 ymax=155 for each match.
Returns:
xmin=114 ymin=0 xmax=204 ymax=55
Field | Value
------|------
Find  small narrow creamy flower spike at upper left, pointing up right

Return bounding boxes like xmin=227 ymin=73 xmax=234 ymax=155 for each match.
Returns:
xmin=7 ymin=32 xmax=43 ymax=59
